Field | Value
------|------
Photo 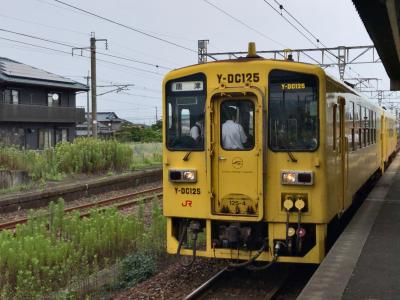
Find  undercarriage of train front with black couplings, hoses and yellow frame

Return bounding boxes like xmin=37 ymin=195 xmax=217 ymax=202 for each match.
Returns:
xmin=167 ymin=218 xmax=327 ymax=266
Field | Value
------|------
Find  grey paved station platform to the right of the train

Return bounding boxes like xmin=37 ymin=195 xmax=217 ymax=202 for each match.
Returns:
xmin=297 ymin=155 xmax=400 ymax=300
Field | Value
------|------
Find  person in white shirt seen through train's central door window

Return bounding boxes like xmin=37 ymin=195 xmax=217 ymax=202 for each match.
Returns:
xmin=222 ymin=106 xmax=247 ymax=150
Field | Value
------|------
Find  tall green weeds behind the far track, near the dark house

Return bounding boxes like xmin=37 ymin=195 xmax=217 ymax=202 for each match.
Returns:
xmin=0 ymin=138 xmax=162 ymax=193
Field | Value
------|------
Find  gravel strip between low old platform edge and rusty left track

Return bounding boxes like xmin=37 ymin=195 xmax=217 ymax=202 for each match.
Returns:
xmin=0 ymin=181 xmax=162 ymax=223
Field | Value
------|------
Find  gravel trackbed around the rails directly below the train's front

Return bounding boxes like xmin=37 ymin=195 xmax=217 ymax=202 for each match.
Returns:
xmin=112 ymin=258 xmax=316 ymax=300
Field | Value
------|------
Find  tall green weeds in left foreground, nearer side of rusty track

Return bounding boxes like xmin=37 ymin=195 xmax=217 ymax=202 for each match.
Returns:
xmin=0 ymin=200 xmax=165 ymax=299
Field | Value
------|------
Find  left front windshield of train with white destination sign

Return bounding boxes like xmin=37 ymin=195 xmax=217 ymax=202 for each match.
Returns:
xmin=166 ymin=74 xmax=206 ymax=151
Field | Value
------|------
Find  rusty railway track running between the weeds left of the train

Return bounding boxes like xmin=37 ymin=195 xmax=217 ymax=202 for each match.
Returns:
xmin=0 ymin=187 xmax=162 ymax=231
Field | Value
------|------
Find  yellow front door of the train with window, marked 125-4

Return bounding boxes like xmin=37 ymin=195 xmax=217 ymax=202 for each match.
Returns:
xmin=212 ymin=94 xmax=263 ymax=220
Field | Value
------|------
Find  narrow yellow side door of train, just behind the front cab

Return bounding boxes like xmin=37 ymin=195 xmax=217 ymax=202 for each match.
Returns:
xmin=338 ymin=97 xmax=349 ymax=210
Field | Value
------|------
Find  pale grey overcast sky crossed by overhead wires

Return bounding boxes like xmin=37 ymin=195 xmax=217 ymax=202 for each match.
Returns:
xmin=0 ymin=0 xmax=389 ymax=124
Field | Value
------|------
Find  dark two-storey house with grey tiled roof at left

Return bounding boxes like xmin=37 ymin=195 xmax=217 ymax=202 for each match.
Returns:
xmin=0 ymin=57 xmax=89 ymax=149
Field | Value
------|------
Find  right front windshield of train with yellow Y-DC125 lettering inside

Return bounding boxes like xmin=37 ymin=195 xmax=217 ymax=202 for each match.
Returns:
xmin=268 ymin=70 xmax=319 ymax=151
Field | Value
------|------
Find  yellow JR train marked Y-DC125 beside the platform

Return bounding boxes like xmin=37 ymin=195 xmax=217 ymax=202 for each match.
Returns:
xmin=163 ymin=45 xmax=397 ymax=265
